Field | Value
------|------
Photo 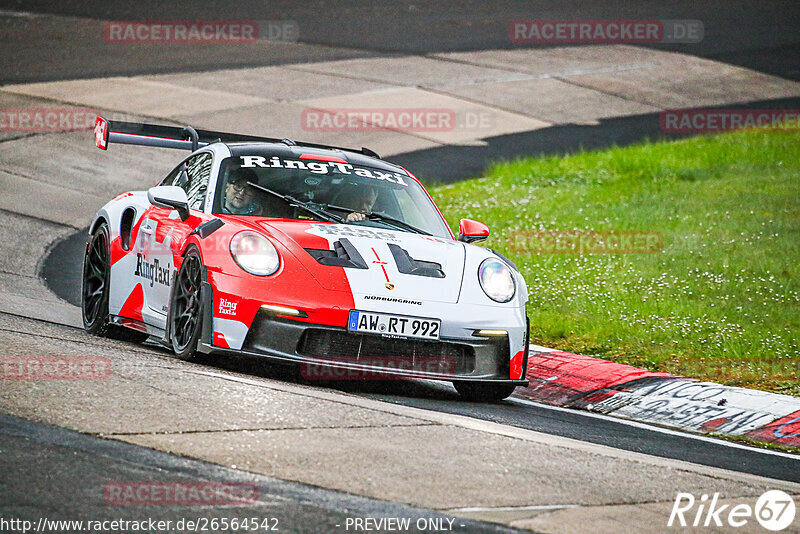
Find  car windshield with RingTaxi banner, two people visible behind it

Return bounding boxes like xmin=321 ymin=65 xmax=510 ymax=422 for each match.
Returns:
xmin=213 ymin=155 xmax=451 ymax=238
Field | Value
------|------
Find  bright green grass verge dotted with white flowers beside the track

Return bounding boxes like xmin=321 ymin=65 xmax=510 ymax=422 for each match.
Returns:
xmin=431 ymin=131 xmax=800 ymax=395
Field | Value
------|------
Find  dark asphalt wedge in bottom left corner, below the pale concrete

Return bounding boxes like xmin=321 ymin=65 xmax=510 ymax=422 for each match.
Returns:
xmin=0 ymin=415 xmax=514 ymax=532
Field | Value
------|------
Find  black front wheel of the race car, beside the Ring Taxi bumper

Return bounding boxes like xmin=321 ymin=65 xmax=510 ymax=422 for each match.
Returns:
xmin=169 ymin=246 xmax=204 ymax=360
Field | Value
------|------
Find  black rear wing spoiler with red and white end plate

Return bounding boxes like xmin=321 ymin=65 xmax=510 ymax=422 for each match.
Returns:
xmin=94 ymin=117 xmax=380 ymax=159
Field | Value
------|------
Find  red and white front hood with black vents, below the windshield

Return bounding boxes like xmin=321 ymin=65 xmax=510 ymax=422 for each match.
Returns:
xmin=258 ymin=219 xmax=465 ymax=303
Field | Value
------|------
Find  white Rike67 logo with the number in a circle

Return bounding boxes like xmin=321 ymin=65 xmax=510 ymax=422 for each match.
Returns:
xmin=667 ymin=490 xmax=797 ymax=532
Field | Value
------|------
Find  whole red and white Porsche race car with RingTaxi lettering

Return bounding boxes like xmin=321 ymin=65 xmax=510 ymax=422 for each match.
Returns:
xmin=82 ymin=117 xmax=529 ymax=400
